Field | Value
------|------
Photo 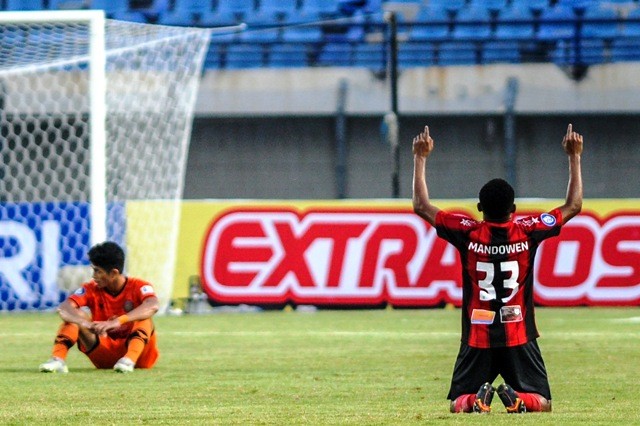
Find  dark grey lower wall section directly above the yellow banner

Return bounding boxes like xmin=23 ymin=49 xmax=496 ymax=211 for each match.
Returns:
xmin=185 ymin=113 xmax=640 ymax=199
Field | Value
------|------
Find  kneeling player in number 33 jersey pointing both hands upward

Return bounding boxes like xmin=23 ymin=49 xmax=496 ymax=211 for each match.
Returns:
xmin=413 ymin=124 xmax=583 ymax=413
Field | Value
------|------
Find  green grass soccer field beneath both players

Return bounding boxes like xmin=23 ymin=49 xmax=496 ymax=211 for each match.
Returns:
xmin=0 ymin=308 xmax=640 ymax=425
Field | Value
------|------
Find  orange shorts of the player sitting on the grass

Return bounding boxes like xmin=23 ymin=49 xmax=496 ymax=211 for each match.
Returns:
xmin=79 ymin=332 xmax=158 ymax=368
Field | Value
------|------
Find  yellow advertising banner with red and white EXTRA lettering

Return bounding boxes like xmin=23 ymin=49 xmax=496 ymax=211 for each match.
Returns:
xmin=174 ymin=200 xmax=640 ymax=307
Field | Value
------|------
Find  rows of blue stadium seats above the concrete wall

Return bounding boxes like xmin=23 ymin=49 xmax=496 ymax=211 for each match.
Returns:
xmin=1 ymin=0 xmax=640 ymax=71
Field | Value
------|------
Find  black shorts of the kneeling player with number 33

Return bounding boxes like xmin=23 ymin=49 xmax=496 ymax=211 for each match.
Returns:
xmin=447 ymin=340 xmax=551 ymax=401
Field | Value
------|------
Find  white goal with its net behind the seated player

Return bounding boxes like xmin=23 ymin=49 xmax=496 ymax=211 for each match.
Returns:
xmin=0 ymin=11 xmax=210 ymax=311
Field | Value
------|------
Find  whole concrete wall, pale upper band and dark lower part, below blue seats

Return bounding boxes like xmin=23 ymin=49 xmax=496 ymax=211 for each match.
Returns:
xmin=185 ymin=63 xmax=640 ymax=199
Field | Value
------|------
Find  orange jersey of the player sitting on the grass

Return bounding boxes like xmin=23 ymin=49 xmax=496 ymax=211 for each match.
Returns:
xmin=69 ymin=277 xmax=156 ymax=339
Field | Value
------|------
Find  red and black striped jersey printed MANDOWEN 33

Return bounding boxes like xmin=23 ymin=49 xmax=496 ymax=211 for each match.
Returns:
xmin=435 ymin=209 xmax=562 ymax=348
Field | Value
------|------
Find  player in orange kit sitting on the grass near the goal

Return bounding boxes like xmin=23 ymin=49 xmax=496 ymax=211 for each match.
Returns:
xmin=40 ymin=241 xmax=159 ymax=373
